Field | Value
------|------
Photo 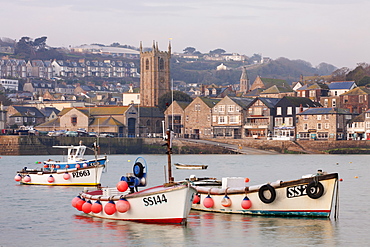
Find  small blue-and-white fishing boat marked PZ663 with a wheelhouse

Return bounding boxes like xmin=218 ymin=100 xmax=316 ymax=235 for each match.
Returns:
xmin=14 ymin=143 xmax=108 ymax=186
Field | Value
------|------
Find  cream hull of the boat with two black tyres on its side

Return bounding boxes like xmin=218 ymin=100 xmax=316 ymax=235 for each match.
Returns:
xmin=192 ymin=173 xmax=338 ymax=217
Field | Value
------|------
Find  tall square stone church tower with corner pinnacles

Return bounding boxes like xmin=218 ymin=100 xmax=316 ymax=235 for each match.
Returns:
xmin=140 ymin=42 xmax=171 ymax=107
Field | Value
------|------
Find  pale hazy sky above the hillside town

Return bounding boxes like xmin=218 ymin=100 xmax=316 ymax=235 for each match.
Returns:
xmin=0 ymin=0 xmax=370 ymax=69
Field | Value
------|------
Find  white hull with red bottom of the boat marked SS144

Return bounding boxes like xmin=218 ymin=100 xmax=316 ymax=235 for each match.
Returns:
xmin=81 ymin=185 xmax=196 ymax=224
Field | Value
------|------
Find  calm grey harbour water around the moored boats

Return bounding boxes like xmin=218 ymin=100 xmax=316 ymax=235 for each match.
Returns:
xmin=0 ymin=155 xmax=370 ymax=247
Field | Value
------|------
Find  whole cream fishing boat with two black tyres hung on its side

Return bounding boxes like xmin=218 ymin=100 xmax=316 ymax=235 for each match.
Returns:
xmin=192 ymin=170 xmax=339 ymax=218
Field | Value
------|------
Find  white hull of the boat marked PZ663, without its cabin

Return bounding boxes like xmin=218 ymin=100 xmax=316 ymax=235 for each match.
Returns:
xmin=18 ymin=165 xmax=105 ymax=186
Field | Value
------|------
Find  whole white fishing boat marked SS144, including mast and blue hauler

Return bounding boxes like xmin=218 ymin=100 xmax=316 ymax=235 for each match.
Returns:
xmin=72 ymin=132 xmax=196 ymax=224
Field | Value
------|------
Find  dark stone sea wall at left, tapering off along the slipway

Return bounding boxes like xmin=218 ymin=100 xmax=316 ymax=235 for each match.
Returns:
xmin=0 ymin=135 xmax=235 ymax=155
